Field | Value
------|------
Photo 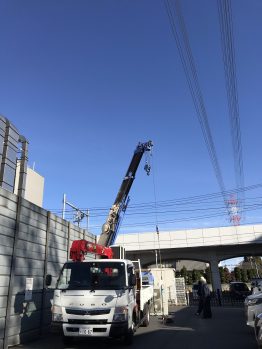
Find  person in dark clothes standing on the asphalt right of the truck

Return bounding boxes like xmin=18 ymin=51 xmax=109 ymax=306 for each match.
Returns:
xmin=196 ymin=276 xmax=212 ymax=319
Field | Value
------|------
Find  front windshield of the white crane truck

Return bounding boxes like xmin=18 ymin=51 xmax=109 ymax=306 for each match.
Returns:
xmin=57 ymin=262 xmax=126 ymax=290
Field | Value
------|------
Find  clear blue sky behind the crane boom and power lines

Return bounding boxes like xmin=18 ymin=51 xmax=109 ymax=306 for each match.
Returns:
xmin=0 ymin=0 xmax=262 ymax=260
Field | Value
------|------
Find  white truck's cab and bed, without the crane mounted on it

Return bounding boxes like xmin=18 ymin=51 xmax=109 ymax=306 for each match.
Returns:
xmin=48 ymin=259 xmax=153 ymax=343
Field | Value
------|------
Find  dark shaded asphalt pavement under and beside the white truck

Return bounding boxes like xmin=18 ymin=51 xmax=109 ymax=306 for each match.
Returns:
xmin=13 ymin=306 xmax=257 ymax=349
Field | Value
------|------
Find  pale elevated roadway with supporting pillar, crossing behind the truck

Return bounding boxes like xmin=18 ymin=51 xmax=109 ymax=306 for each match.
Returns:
xmin=116 ymin=224 xmax=262 ymax=290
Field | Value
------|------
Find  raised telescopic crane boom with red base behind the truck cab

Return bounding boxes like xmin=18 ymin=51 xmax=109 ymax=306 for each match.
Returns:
xmin=70 ymin=141 xmax=153 ymax=261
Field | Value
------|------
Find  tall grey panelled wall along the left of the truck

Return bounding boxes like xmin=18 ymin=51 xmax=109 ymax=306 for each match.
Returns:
xmin=0 ymin=188 xmax=95 ymax=349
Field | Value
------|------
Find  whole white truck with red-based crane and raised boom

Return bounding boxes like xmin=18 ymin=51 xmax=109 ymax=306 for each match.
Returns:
xmin=46 ymin=141 xmax=153 ymax=344
